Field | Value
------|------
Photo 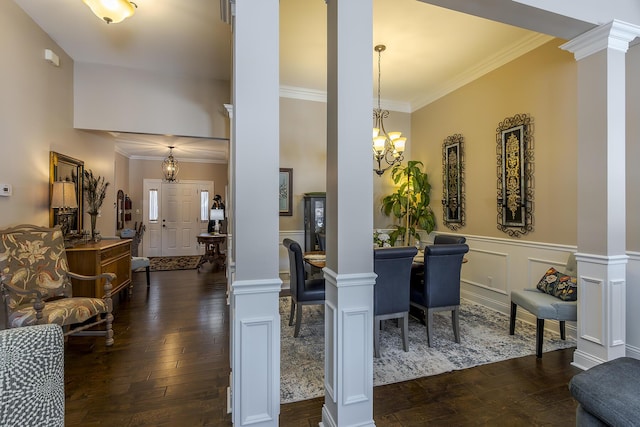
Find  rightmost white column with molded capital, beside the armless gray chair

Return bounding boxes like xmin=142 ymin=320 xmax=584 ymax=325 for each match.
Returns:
xmin=561 ymin=21 xmax=640 ymax=369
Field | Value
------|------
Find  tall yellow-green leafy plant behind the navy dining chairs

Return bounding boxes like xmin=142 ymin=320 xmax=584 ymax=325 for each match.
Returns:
xmin=381 ymin=160 xmax=436 ymax=246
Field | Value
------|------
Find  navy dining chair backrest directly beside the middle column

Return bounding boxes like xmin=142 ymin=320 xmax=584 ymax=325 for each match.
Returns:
xmin=373 ymin=246 xmax=418 ymax=316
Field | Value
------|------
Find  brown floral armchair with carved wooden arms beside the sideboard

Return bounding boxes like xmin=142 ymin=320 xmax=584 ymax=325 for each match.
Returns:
xmin=0 ymin=225 xmax=116 ymax=346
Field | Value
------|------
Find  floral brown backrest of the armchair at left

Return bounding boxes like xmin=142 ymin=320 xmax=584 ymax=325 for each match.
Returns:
xmin=0 ymin=225 xmax=72 ymax=315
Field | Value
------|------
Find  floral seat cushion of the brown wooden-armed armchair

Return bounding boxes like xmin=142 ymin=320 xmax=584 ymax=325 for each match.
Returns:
xmin=9 ymin=297 xmax=107 ymax=328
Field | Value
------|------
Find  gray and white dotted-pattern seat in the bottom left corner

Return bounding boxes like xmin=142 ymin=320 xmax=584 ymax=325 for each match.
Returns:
xmin=0 ymin=324 xmax=64 ymax=427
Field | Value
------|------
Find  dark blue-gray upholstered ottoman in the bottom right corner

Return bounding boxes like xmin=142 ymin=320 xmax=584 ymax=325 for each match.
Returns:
xmin=569 ymin=357 xmax=640 ymax=426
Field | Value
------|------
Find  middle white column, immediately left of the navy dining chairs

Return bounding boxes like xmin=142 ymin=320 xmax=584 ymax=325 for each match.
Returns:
xmin=322 ymin=0 xmax=375 ymax=426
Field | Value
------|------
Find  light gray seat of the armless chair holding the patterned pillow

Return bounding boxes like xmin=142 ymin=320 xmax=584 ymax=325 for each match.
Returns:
xmin=511 ymin=288 xmax=578 ymax=321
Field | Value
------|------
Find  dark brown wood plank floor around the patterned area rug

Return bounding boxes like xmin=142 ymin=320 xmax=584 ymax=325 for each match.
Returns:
xmin=65 ymin=270 xmax=578 ymax=427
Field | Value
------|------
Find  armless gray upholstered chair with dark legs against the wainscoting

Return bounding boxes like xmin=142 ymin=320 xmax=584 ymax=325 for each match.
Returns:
xmin=509 ymin=253 xmax=578 ymax=358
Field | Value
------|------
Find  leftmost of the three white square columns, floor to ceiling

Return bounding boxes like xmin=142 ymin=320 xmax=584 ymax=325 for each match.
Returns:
xmin=230 ymin=0 xmax=282 ymax=427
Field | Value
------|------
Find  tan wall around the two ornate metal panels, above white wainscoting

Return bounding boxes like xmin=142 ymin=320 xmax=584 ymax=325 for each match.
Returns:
xmin=411 ymin=40 xmax=577 ymax=245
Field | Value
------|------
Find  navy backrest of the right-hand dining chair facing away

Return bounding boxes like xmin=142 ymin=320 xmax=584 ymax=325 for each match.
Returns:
xmin=422 ymin=243 xmax=469 ymax=308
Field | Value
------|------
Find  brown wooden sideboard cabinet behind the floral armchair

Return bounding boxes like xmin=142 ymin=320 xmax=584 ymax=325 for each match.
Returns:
xmin=67 ymin=239 xmax=131 ymax=298
